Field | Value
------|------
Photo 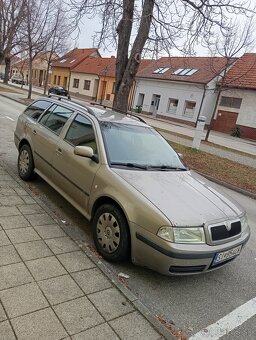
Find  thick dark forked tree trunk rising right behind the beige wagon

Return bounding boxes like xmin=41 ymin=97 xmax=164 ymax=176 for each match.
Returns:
xmin=113 ymin=0 xmax=154 ymax=112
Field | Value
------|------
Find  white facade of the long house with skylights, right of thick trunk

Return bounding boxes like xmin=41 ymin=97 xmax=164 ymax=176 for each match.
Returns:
xmin=133 ymin=78 xmax=216 ymax=124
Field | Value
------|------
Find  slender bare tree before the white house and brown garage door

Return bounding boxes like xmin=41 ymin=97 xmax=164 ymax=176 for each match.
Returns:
xmin=205 ymin=18 xmax=255 ymax=141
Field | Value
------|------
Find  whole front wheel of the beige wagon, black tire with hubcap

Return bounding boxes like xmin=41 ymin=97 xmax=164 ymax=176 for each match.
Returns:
xmin=93 ymin=204 xmax=131 ymax=262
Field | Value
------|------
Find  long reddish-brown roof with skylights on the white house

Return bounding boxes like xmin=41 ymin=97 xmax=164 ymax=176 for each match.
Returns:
xmin=137 ymin=57 xmax=235 ymax=84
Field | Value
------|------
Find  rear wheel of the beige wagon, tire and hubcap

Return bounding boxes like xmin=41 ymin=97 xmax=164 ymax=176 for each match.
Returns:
xmin=18 ymin=144 xmax=34 ymax=181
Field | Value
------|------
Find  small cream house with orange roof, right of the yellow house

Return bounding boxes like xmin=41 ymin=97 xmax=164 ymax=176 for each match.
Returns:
xmin=69 ymin=57 xmax=116 ymax=101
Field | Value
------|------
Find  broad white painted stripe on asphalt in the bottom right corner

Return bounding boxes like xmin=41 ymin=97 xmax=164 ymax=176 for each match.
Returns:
xmin=189 ymin=298 xmax=256 ymax=340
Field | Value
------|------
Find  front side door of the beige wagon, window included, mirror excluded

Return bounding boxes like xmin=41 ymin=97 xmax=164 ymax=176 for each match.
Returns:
xmin=53 ymin=114 xmax=100 ymax=212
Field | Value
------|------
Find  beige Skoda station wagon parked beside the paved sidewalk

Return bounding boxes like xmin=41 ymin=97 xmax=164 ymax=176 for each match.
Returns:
xmin=14 ymin=97 xmax=250 ymax=275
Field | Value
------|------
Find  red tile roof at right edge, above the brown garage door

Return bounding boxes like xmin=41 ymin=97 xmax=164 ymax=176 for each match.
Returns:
xmin=224 ymin=53 xmax=256 ymax=90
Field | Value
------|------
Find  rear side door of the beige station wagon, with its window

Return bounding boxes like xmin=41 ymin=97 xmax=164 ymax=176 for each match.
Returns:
xmin=32 ymin=104 xmax=74 ymax=180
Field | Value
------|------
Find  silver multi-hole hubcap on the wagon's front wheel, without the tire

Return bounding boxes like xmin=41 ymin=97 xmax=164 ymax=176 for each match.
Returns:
xmin=97 ymin=213 xmax=120 ymax=254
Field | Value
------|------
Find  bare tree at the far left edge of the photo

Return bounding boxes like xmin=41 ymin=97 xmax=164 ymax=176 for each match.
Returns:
xmin=0 ymin=0 xmax=25 ymax=83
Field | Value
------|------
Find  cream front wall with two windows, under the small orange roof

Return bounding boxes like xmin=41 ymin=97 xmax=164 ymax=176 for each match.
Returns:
xmin=69 ymin=72 xmax=99 ymax=100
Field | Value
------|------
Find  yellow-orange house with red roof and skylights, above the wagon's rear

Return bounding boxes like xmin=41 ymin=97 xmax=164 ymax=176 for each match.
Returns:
xmin=51 ymin=48 xmax=100 ymax=90
